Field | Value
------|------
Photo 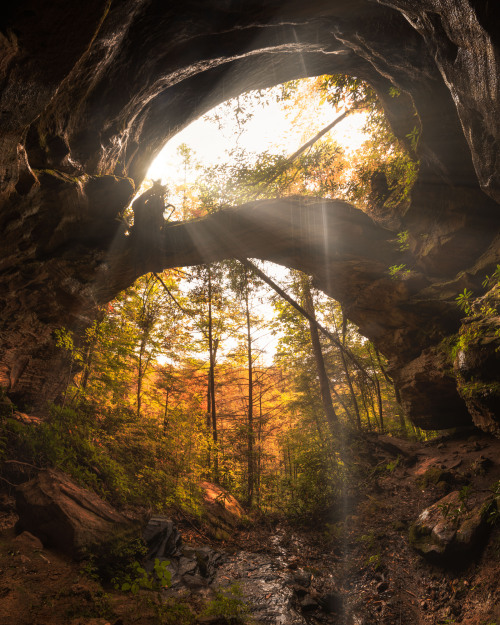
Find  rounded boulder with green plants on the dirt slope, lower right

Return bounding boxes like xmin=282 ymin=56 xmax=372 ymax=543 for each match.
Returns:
xmin=410 ymin=491 xmax=496 ymax=564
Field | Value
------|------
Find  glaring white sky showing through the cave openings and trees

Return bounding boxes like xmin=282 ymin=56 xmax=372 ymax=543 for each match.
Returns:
xmin=145 ymin=79 xmax=366 ymax=364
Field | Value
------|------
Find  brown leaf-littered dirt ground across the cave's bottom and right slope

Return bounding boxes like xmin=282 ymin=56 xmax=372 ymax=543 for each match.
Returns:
xmin=0 ymin=433 xmax=500 ymax=625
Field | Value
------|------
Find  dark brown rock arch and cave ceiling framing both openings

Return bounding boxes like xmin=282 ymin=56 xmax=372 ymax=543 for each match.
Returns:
xmin=0 ymin=0 xmax=500 ymax=431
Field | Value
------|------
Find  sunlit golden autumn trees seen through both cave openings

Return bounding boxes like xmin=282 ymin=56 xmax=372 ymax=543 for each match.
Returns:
xmin=0 ymin=76 xmax=419 ymax=516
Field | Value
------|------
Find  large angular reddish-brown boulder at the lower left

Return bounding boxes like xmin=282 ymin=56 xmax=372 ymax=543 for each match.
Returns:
xmin=16 ymin=469 xmax=137 ymax=559
